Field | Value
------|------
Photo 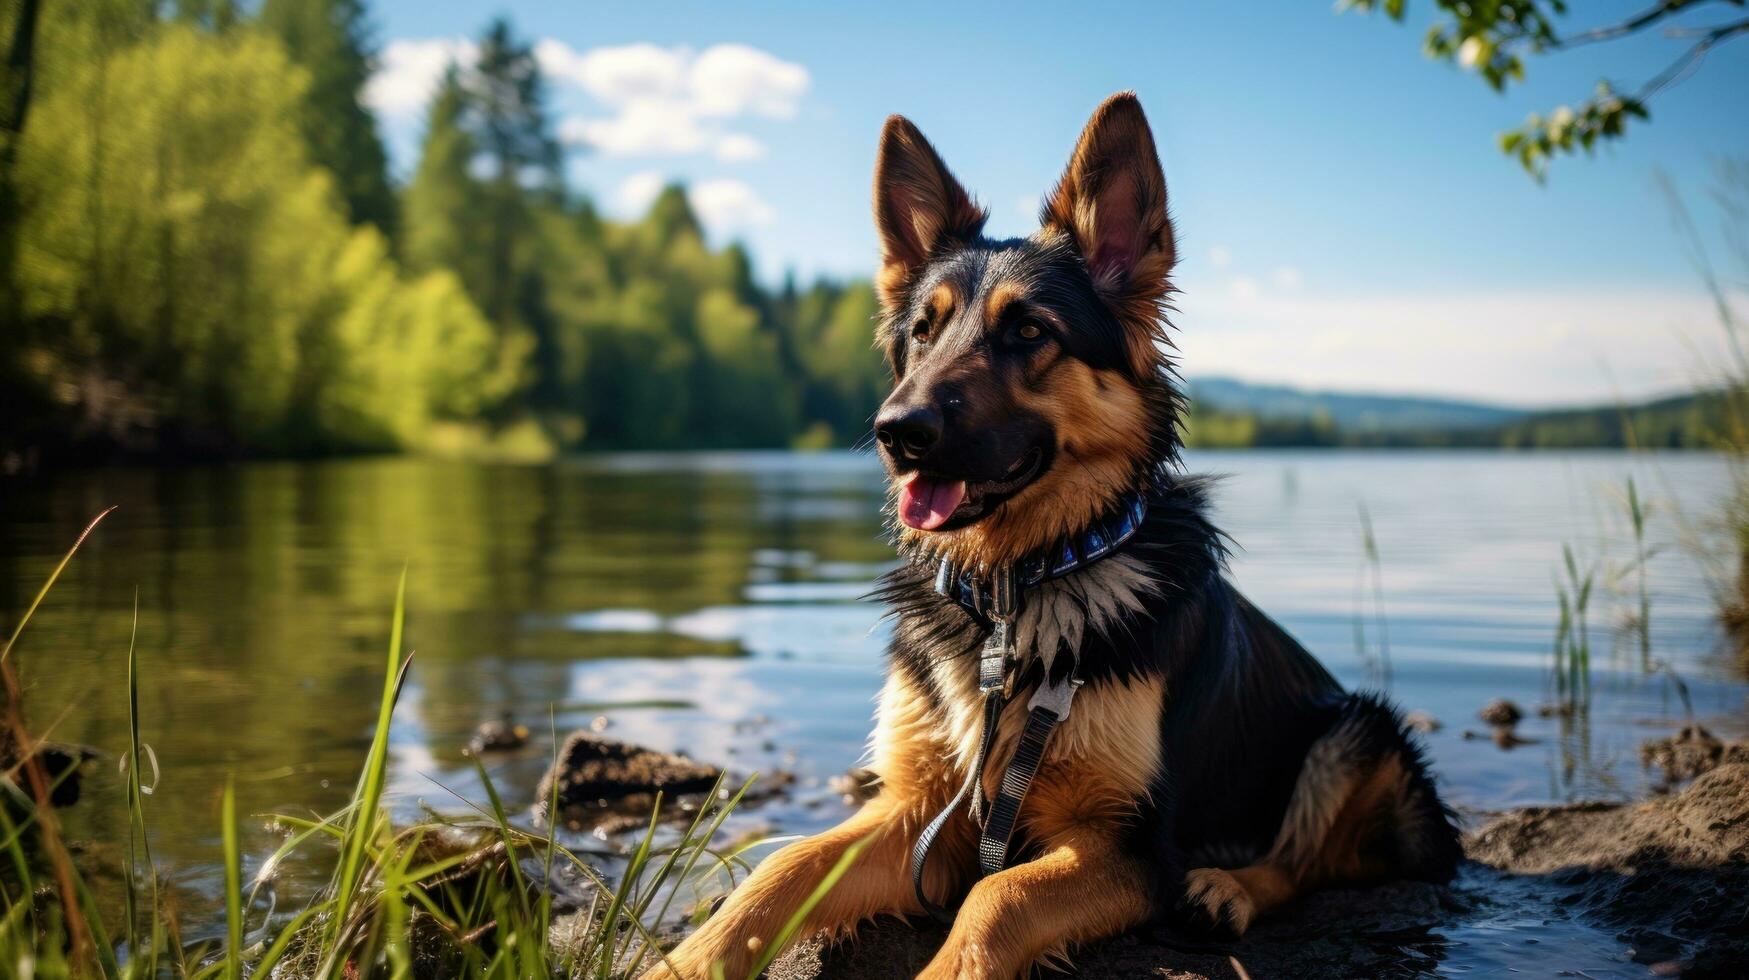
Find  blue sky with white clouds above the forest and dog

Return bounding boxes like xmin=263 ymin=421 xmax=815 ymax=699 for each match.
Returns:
xmin=362 ymin=0 xmax=1749 ymax=404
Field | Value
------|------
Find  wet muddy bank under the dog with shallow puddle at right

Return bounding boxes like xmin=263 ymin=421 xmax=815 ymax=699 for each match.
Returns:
xmin=770 ymin=763 xmax=1749 ymax=980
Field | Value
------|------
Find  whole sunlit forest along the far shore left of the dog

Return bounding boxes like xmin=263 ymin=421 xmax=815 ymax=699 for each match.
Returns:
xmin=0 ymin=0 xmax=885 ymax=459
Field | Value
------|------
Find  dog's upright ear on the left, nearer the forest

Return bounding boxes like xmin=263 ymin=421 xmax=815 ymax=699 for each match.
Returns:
xmin=875 ymin=116 xmax=990 ymax=308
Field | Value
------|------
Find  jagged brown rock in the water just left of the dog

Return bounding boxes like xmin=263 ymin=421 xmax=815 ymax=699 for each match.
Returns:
xmin=535 ymin=732 xmax=722 ymax=814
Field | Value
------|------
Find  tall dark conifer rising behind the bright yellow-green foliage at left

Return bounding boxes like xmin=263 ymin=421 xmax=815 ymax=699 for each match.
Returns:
xmin=261 ymin=0 xmax=395 ymax=235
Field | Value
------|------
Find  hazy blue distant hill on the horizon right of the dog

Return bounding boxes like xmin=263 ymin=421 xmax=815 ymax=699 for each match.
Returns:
xmin=1186 ymin=378 xmax=1530 ymax=434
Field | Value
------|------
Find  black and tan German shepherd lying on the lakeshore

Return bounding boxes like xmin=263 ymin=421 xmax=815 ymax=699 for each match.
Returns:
xmin=654 ymin=93 xmax=1460 ymax=980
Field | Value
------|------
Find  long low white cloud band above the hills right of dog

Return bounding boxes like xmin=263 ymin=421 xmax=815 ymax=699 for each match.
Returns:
xmin=1174 ymin=280 xmax=1749 ymax=404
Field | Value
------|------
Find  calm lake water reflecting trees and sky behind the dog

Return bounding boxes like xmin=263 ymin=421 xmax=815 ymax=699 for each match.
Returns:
xmin=0 ymin=452 xmax=1749 ymax=975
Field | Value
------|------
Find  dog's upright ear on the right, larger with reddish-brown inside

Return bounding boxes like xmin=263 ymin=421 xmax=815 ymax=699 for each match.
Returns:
xmin=1039 ymin=93 xmax=1177 ymax=371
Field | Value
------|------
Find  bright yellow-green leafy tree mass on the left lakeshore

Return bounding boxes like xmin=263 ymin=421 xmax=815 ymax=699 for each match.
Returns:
xmin=17 ymin=26 xmax=500 ymax=452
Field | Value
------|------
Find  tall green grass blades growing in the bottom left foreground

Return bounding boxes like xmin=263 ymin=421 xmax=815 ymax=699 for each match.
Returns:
xmin=0 ymin=511 xmax=818 ymax=980
